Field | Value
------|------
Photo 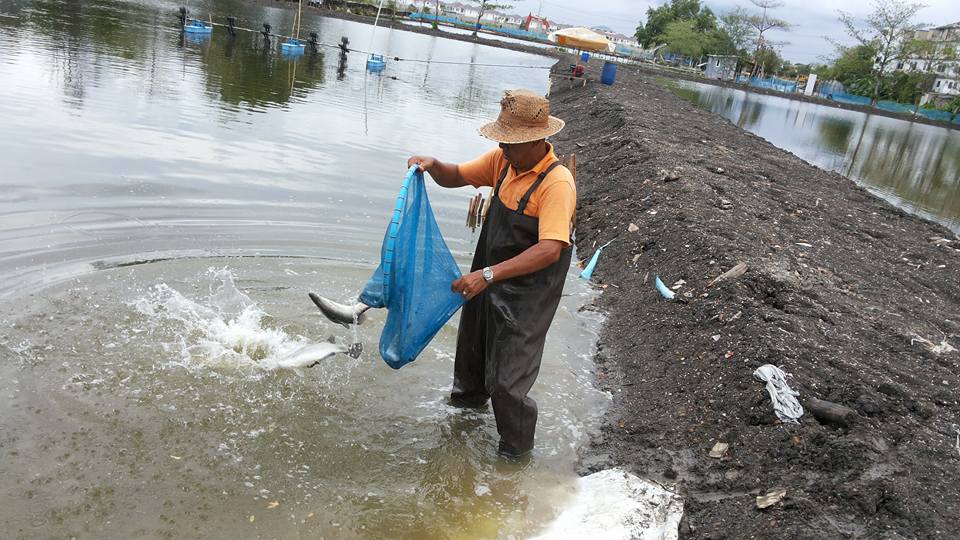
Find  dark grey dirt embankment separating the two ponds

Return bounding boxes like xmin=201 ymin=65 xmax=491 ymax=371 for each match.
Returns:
xmin=551 ymin=62 xmax=960 ymax=539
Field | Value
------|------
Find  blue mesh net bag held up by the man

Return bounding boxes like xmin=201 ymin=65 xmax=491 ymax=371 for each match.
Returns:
xmin=360 ymin=166 xmax=463 ymax=369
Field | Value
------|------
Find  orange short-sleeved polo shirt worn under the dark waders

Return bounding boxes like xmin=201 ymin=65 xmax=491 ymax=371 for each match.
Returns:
xmin=458 ymin=143 xmax=577 ymax=246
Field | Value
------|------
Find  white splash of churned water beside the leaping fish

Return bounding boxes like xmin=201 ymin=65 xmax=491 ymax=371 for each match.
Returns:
xmin=134 ymin=268 xmax=344 ymax=370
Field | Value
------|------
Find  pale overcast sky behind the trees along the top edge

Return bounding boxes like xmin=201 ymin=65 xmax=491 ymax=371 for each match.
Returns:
xmin=506 ymin=0 xmax=960 ymax=63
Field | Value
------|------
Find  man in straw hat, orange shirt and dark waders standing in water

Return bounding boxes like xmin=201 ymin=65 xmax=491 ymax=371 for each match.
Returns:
xmin=407 ymin=90 xmax=577 ymax=457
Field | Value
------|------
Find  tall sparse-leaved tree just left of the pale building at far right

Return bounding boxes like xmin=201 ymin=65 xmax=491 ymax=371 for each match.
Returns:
xmin=840 ymin=0 xmax=925 ymax=105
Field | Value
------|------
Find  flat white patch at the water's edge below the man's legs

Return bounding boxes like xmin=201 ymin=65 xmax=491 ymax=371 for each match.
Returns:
xmin=535 ymin=469 xmax=683 ymax=540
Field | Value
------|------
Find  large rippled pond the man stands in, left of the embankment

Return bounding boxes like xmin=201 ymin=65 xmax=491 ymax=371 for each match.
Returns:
xmin=0 ymin=0 xmax=608 ymax=538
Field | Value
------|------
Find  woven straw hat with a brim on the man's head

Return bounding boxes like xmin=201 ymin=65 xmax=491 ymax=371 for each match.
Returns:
xmin=479 ymin=90 xmax=564 ymax=144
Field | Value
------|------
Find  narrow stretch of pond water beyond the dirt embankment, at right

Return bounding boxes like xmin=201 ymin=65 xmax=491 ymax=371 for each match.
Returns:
xmin=670 ymin=80 xmax=960 ymax=233
